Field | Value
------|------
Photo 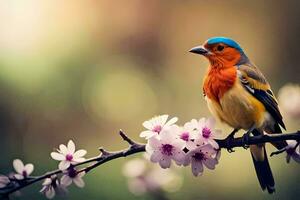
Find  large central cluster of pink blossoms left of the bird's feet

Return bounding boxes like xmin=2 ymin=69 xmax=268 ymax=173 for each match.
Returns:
xmin=140 ymin=115 xmax=221 ymax=176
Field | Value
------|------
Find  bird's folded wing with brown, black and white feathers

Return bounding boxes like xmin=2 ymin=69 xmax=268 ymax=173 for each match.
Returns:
xmin=237 ymin=64 xmax=285 ymax=129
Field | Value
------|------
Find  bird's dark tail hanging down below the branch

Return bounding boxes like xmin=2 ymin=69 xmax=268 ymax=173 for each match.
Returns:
xmin=250 ymin=145 xmax=275 ymax=194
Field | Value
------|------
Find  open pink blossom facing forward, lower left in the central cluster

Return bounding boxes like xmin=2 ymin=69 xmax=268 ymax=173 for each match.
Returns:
xmin=146 ymin=131 xmax=185 ymax=169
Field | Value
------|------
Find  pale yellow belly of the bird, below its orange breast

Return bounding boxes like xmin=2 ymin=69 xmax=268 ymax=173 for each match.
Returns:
xmin=206 ymin=81 xmax=266 ymax=130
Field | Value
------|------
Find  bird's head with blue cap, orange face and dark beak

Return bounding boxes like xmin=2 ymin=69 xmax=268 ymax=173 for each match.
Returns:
xmin=190 ymin=37 xmax=249 ymax=67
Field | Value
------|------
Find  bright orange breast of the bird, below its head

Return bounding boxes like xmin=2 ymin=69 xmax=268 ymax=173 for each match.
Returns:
xmin=203 ymin=66 xmax=237 ymax=102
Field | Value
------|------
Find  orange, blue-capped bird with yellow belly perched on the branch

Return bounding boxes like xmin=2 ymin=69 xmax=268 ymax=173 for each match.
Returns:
xmin=190 ymin=37 xmax=287 ymax=194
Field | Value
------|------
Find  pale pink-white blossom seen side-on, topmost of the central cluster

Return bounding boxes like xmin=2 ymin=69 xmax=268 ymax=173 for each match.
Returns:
xmin=140 ymin=115 xmax=178 ymax=139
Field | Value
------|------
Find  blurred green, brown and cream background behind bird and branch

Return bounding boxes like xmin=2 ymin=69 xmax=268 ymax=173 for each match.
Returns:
xmin=0 ymin=0 xmax=300 ymax=200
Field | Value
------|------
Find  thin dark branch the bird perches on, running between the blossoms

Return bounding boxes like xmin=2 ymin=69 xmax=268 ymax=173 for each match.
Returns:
xmin=0 ymin=130 xmax=300 ymax=198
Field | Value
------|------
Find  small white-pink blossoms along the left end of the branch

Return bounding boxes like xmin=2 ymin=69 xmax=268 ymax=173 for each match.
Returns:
xmin=0 ymin=140 xmax=87 ymax=199
